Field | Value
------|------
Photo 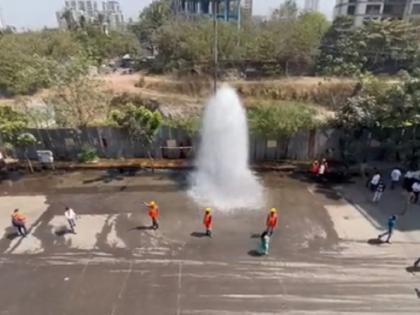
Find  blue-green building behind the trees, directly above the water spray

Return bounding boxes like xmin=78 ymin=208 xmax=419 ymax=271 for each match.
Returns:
xmin=172 ymin=0 xmax=241 ymax=21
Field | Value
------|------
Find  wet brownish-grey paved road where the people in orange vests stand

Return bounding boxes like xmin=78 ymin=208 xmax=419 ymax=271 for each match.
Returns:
xmin=0 ymin=172 xmax=420 ymax=315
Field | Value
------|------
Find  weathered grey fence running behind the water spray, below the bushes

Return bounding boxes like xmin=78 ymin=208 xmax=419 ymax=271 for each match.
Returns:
xmin=4 ymin=127 xmax=339 ymax=162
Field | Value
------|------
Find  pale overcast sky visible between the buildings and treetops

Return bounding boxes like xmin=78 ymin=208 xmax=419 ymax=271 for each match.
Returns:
xmin=0 ymin=0 xmax=335 ymax=29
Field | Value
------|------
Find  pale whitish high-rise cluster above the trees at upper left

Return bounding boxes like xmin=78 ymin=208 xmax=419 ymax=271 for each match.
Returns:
xmin=56 ymin=0 xmax=125 ymax=30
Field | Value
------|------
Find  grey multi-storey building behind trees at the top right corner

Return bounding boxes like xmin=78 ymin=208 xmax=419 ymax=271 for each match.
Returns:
xmin=334 ymin=0 xmax=420 ymax=26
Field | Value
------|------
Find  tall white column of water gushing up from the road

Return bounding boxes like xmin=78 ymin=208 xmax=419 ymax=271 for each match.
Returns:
xmin=190 ymin=86 xmax=263 ymax=211
